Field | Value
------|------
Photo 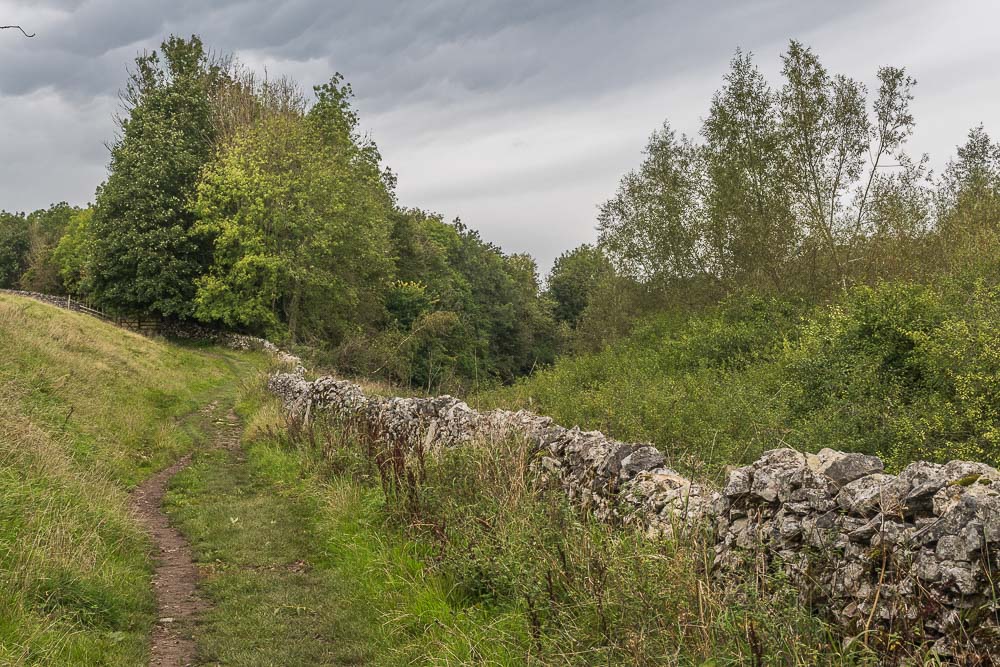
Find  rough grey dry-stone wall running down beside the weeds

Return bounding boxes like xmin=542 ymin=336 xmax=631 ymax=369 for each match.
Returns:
xmin=269 ymin=372 xmax=1000 ymax=664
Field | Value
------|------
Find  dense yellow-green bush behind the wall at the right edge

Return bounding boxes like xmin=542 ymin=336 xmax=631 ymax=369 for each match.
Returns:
xmin=788 ymin=284 xmax=1000 ymax=467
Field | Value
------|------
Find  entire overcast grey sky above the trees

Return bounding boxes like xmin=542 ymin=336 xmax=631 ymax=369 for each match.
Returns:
xmin=0 ymin=0 xmax=1000 ymax=271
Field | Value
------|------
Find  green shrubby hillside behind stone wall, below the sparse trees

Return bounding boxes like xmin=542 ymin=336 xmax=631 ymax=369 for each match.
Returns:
xmin=474 ymin=281 xmax=1000 ymax=480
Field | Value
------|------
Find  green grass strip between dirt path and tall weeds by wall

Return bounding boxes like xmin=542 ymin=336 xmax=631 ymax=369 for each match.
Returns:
xmin=161 ymin=386 xmax=519 ymax=665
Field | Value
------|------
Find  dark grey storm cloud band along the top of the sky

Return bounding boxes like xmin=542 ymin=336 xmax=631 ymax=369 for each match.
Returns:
xmin=0 ymin=0 xmax=861 ymax=106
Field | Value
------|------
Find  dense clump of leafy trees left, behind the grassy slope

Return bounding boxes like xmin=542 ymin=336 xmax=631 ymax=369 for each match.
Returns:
xmin=0 ymin=37 xmax=557 ymax=389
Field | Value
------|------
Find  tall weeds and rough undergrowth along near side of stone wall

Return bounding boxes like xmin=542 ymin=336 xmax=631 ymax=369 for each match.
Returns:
xmin=242 ymin=374 xmax=892 ymax=666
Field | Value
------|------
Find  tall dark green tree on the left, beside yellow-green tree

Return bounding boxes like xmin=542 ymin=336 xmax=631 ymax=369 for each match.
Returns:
xmin=88 ymin=37 xmax=221 ymax=318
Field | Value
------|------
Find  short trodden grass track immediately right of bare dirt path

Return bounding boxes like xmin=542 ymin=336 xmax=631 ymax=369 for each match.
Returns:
xmin=166 ymin=410 xmax=384 ymax=666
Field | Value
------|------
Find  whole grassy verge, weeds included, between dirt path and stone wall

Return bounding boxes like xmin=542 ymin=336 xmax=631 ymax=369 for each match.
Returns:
xmin=197 ymin=378 xmax=874 ymax=666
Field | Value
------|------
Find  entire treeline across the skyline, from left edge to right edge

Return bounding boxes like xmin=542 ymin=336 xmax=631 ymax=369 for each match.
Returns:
xmin=7 ymin=37 xmax=1000 ymax=391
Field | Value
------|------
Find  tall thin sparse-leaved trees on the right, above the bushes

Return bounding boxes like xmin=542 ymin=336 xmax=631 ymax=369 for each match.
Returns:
xmin=549 ymin=41 xmax=1000 ymax=349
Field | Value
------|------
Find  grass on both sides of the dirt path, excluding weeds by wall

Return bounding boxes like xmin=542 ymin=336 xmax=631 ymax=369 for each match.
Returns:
xmin=0 ymin=296 xmax=517 ymax=666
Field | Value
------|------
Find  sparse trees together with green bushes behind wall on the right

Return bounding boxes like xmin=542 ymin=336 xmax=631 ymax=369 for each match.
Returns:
xmin=478 ymin=42 xmax=1000 ymax=483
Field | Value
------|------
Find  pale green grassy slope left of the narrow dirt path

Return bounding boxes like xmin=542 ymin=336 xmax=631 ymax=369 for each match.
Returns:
xmin=0 ymin=295 xmax=262 ymax=665
